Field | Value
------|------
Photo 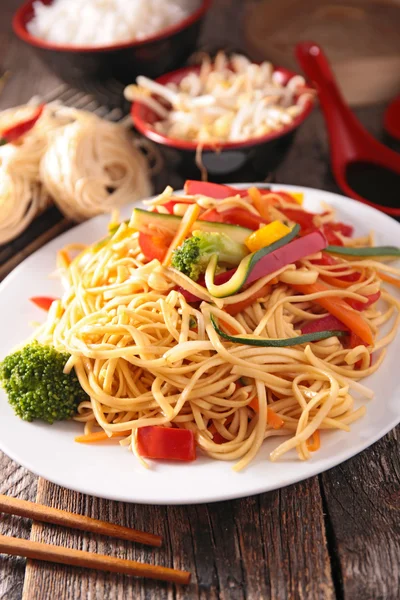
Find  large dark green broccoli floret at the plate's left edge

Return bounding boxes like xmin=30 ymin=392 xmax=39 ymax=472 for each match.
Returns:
xmin=0 ymin=342 xmax=88 ymax=423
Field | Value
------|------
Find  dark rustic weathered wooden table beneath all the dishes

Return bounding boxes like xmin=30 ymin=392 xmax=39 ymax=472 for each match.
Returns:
xmin=0 ymin=0 xmax=400 ymax=600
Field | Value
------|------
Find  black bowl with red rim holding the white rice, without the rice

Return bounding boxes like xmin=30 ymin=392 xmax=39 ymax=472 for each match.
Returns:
xmin=13 ymin=0 xmax=212 ymax=86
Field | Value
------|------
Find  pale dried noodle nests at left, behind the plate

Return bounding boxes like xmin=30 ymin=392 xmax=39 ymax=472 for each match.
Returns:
xmin=0 ymin=104 xmax=151 ymax=244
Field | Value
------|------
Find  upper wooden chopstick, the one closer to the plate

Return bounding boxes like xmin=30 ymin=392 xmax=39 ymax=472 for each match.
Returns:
xmin=0 ymin=494 xmax=162 ymax=548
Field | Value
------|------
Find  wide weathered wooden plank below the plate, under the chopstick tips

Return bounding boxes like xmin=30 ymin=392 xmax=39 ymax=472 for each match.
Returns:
xmin=23 ymin=478 xmax=334 ymax=600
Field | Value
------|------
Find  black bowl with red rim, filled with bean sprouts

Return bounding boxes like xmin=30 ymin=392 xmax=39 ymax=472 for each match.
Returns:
xmin=125 ymin=52 xmax=316 ymax=181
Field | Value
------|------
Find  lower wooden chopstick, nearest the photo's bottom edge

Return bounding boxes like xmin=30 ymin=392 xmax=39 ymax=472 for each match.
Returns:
xmin=0 ymin=535 xmax=191 ymax=584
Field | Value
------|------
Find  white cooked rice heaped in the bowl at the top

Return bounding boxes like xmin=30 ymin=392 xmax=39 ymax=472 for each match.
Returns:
xmin=27 ymin=0 xmax=199 ymax=46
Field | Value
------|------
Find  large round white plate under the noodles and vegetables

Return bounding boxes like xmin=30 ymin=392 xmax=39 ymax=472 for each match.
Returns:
xmin=0 ymin=185 xmax=400 ymax=504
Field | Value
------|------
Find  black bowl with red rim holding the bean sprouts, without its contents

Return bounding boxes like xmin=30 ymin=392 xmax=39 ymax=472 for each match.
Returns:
xmin=131 ymin=66 xmax=314 ymax=181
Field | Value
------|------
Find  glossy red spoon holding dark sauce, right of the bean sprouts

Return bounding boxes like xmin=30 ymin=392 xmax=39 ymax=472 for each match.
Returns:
xmin=296 ymin=42 xmax=400 ymax=217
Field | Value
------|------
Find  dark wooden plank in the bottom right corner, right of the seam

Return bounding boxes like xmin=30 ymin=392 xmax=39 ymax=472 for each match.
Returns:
xmin=321 ymin=427 xmax=400 ymax=600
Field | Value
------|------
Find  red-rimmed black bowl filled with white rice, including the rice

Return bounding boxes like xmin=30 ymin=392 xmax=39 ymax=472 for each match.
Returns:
xmin=13 ymin=0 xmax=212 ymax=85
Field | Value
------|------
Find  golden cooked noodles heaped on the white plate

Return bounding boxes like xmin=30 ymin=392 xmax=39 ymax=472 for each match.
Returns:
xmin=35 ymin=190 xmax=399 ymax=470
